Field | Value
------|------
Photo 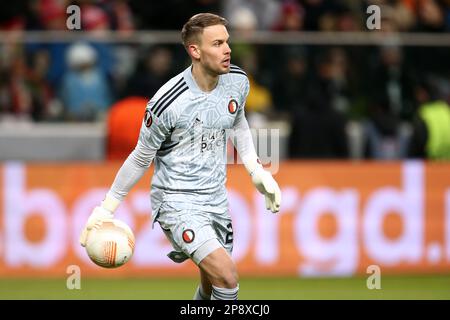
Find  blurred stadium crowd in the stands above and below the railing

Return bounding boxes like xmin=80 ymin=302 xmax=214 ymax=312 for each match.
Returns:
xmin=0 ymin=0 xmax=450 ymax=159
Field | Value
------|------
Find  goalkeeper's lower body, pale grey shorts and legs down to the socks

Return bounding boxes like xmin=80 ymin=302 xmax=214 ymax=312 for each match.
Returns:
xmin=158 ymin=203 xmax=238 ymax=299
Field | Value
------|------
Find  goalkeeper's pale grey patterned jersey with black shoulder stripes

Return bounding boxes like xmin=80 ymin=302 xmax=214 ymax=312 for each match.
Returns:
xmin=109 ymin=65 xmax=256 ymax=216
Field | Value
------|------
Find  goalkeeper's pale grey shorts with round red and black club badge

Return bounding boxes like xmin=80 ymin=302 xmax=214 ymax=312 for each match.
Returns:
xmin=155 ymin=202 xmax=233 ymax=264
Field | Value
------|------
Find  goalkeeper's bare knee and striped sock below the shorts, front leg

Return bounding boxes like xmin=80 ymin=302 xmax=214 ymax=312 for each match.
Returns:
xmin=198 ymin=247 xmax=239 ymax=300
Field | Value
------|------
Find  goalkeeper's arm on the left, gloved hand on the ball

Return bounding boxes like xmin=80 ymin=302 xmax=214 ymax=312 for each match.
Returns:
xmin=80 ymin=99 xmax=176 ymax=246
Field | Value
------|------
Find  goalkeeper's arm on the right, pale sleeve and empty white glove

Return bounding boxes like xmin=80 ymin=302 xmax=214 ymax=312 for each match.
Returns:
xmin=232 ymin=79 xmax=281 ymax=213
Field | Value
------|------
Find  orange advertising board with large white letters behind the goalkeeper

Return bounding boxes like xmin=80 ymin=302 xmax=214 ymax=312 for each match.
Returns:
xmin=0 ymin=162 xmax=450 ymax=277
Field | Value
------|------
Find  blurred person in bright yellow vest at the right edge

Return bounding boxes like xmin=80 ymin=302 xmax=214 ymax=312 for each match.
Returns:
xmin=409 ymin=77 xmax=450 ymax=160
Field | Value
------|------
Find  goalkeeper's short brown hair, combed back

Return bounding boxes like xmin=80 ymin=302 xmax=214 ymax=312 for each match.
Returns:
xmin=181 ymin=13 xmax=228 ymax=48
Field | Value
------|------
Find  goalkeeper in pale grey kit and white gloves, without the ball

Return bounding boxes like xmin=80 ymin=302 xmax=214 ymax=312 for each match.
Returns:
xmin=80 ymin=13 xmax=281 ymax=300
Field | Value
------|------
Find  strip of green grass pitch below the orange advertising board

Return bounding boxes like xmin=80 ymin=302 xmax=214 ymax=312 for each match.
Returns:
xmin=0 ymin=275 xmax=450 ymax=300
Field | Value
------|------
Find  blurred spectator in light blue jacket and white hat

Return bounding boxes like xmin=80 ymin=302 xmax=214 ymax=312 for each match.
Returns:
xmin=60 ymin=43 xmax=112 ymax=121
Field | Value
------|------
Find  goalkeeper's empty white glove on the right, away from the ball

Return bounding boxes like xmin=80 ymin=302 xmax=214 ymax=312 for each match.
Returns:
xmin=251 ymin=167 xmax=281 ymax=213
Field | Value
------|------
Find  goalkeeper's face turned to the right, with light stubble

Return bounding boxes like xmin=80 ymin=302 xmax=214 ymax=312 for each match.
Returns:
xmin=199 ymin=24 xmax=231 ymax=74
